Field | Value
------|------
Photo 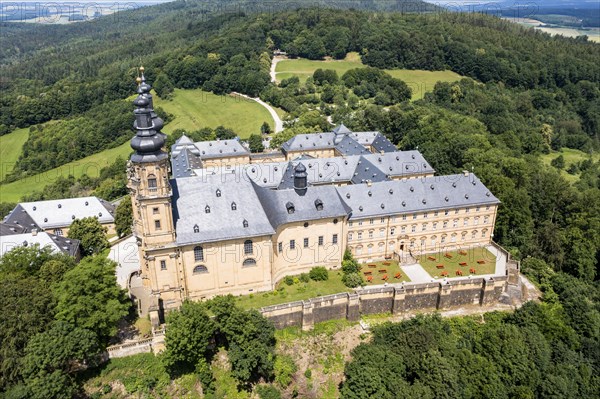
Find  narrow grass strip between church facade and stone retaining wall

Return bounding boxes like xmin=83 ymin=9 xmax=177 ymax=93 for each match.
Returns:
xmin=237 ymin=270 xmax=352 ymax=309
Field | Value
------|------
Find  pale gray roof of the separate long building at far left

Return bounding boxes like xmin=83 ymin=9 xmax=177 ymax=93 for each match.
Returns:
xmin=4 ymin=197 xmax=115 ymax=229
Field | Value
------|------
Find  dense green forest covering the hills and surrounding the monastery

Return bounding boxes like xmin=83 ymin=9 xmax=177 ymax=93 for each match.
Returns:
xmin=0 ymin=1 xmax=600 ymax=399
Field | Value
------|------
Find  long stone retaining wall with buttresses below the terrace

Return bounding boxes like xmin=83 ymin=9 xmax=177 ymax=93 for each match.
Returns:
xmin=260 ymin=276 xmax=508 ymax=330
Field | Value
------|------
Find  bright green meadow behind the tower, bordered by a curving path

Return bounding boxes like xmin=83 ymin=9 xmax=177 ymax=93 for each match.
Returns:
xmin=154 ymin=89 xmax=275 ymax=138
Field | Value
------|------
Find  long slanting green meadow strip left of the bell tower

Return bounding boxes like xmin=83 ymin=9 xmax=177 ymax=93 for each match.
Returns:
xmin=0 ymin=142 xmax=132 ymax=202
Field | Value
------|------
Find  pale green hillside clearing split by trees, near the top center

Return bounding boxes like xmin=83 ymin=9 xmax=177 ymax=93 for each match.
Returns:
xmin=275 ymin=53 xmax=461 ymax=100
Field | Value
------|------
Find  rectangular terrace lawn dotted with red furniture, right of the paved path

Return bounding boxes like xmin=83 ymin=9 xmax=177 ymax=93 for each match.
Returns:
xmin=417 ymin=247 xmax=496 ymax=278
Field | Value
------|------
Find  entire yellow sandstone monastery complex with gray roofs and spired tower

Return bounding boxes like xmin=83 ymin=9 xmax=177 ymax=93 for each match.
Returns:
xmin=128 ymin=69 xmax=499 ymax=310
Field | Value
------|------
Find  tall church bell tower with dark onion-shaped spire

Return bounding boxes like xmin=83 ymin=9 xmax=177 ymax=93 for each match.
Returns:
xmin=127 ymin=67 xmax=175 ymax=248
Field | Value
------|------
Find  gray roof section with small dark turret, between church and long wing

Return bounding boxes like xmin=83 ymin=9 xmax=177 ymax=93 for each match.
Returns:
xmin=255 ymin=186 xmax=350 ymax=229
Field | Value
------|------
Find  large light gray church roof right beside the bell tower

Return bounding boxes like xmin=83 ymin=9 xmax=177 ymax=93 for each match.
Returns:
xmin=171 ymin=173 xmax=274 ymax=245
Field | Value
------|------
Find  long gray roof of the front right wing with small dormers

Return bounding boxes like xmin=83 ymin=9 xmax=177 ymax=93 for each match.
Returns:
xmin=338 ymin=173 xmax=500 ymax=219
